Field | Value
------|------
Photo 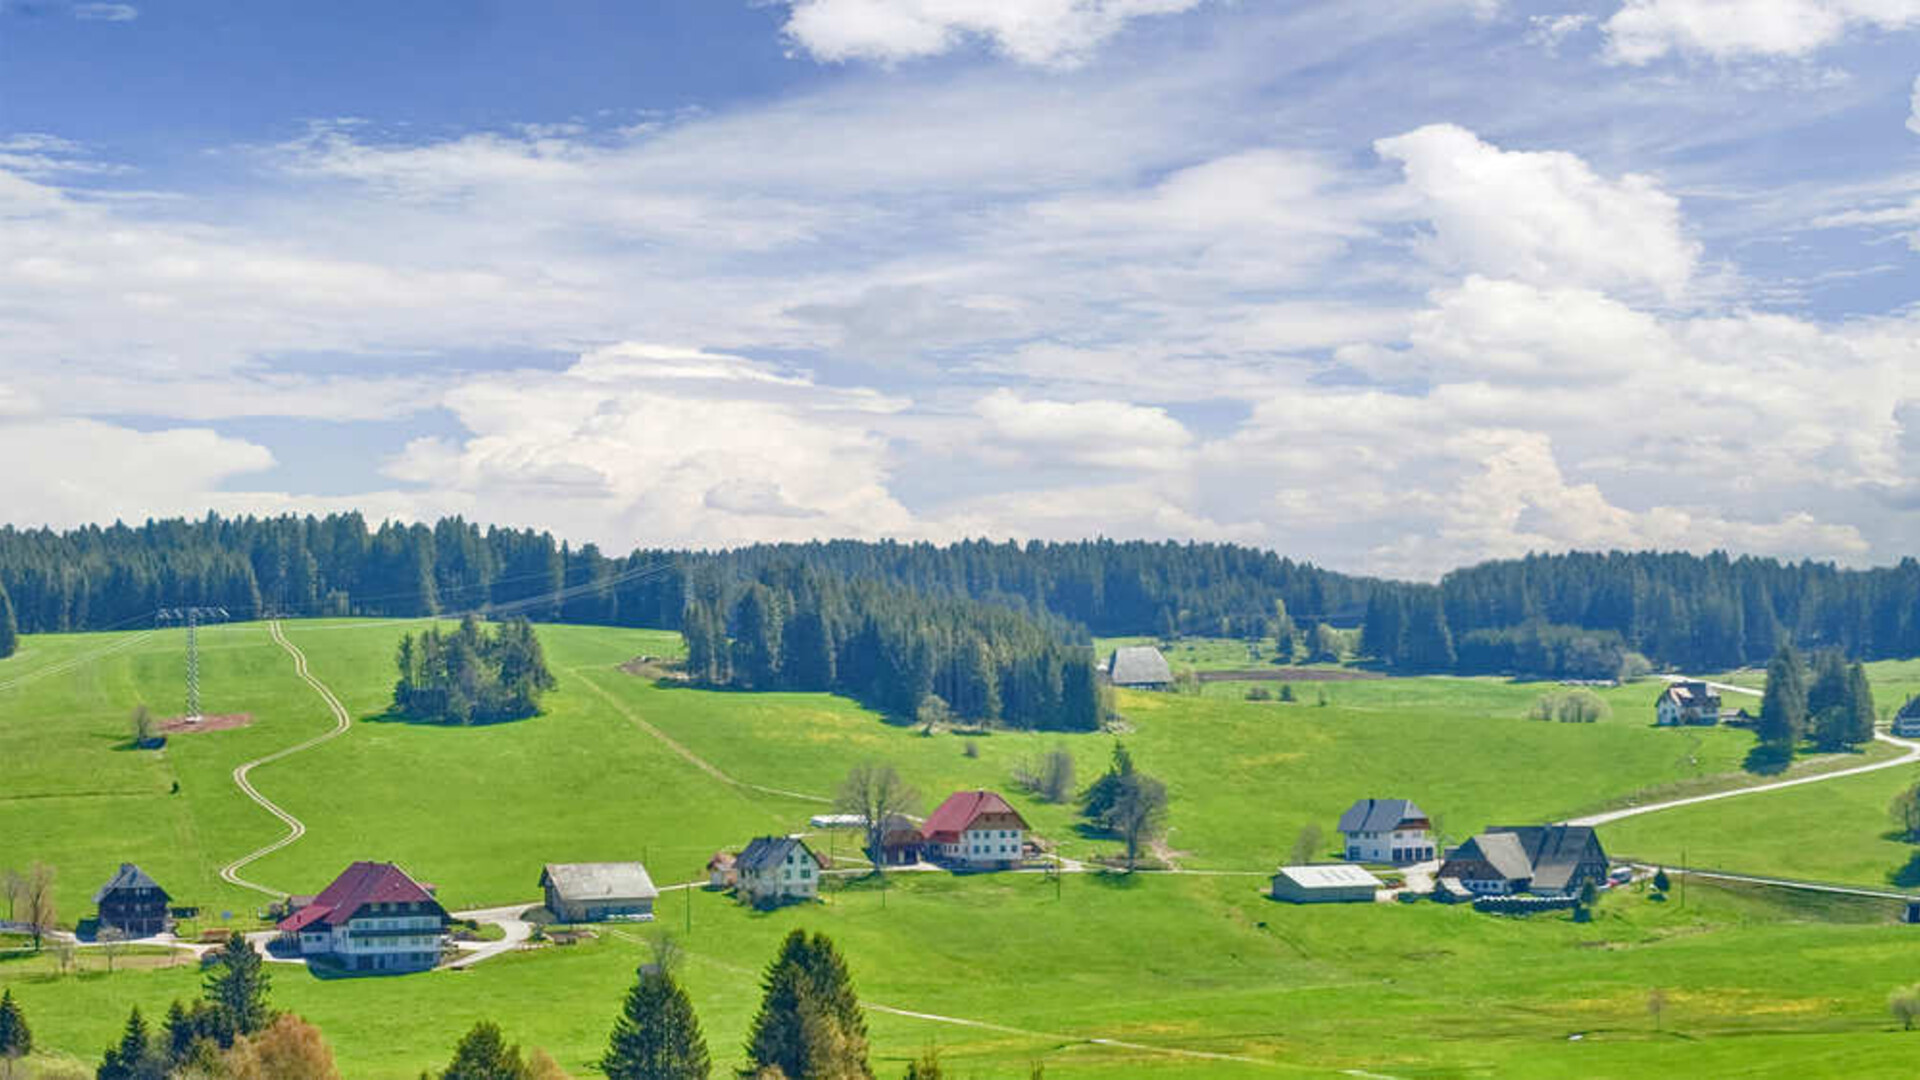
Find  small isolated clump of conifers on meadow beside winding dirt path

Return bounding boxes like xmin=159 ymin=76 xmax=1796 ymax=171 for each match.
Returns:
xmin=394 ymin=615 xmax=555 ymax=724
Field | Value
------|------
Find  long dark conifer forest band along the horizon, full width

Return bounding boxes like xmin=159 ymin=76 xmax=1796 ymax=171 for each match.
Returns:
xmin=0 ymin=513 xmax=1920 ymax=676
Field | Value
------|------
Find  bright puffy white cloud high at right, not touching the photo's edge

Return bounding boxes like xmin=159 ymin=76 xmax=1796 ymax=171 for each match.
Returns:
xmin=1375 ymin=125 xmax=1699 ymax=300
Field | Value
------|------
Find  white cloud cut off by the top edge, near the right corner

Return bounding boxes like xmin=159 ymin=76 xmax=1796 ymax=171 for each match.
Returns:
xmin=1605 ymin=0 xmax=1920 ymax=63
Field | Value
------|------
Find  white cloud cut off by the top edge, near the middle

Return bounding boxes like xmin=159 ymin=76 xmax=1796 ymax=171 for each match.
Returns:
xmin=787 ymin=0 xmax=1202 ymax=67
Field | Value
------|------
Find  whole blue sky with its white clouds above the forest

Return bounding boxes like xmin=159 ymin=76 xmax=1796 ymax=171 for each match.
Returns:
xmin=0 ymin=0 xmax=1920 ymax=577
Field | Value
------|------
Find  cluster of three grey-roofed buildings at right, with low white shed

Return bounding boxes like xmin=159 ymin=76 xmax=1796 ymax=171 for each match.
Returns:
xmin=1271 ymin=799 xmax=1607 ymax=903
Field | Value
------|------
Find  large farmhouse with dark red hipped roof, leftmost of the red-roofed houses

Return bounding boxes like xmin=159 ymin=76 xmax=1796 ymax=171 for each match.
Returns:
xmin=280 ymin=863 xmax=447 ymax=970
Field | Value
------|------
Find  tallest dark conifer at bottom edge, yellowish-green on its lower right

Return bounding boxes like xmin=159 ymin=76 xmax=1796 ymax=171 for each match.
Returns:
xmin=747 ymin=930 xmax=874 ymax=1080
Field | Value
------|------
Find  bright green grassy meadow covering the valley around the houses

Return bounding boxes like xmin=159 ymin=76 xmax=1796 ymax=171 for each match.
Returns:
xmin=0 ymin=621 xmax=1920 ymax=1078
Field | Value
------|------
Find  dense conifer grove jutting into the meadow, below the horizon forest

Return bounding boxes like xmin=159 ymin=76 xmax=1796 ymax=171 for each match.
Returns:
xmin=682 ymin=565 xmax=1102 ymax=730
